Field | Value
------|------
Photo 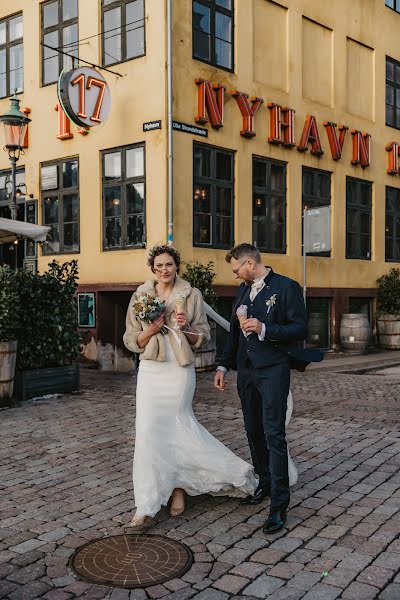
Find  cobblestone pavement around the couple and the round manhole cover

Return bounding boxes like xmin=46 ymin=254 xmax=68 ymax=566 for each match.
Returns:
xmin=0 ymin=361 xmax=400 ymax=600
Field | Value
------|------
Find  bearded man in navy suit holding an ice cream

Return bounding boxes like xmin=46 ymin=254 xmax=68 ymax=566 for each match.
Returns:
xmin=214 ymin=244 xmax=310 ymax=533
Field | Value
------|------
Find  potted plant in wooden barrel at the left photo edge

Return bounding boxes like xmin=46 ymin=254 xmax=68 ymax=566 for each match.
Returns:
xmin=0 ymin=265 xmax=20 ymax=403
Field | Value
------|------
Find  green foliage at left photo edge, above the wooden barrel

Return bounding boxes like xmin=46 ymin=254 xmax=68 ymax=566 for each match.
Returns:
xmin=0 ymin=265 xmax=20 ymax=342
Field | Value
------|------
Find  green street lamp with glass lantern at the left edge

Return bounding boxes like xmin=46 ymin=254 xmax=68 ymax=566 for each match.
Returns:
xmin=0 ymin=94 xmax=30 ymax=220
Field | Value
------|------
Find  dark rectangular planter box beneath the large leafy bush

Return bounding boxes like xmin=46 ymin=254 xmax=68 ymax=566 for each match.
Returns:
xmin=14 ymin=364 xmax=80 ymax=400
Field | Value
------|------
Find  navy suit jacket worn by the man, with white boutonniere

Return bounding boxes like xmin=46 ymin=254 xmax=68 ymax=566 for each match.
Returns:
xmin=219 ymin=269 xmax=323 ymax=371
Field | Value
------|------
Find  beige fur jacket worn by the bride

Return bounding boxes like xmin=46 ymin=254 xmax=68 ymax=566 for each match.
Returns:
xmin=124 ymin=276 xmax=210 ymax=367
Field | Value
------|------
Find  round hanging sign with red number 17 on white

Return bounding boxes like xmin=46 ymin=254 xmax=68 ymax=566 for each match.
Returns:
xmin=57 ymin=67 xmax=111 ymax=128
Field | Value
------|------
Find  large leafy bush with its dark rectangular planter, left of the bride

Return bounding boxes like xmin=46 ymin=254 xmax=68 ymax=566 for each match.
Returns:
xmin=15 ymin=260 xmax=80 ymax=400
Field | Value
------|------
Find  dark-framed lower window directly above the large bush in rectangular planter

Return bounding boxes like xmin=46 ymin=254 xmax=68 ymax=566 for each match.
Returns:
xmin=40 ymin=158 xmax=79 ymax=254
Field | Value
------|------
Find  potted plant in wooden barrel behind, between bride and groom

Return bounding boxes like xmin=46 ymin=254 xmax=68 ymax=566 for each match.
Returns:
xmin=182 ymin=260 xmax=217 ymax=371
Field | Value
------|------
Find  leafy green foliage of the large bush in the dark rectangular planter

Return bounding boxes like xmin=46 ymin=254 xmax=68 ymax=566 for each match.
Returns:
xmin=17 ymin=260 xmax=81 ymax=370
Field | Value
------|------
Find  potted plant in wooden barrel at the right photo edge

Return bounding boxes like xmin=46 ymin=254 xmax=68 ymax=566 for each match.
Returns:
xmin=376 ymin=267 xmax=400 ymax=350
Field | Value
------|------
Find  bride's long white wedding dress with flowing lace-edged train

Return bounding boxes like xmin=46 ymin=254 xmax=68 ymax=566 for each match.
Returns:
xmin=133 ymin=335 xmax=257 ymax=517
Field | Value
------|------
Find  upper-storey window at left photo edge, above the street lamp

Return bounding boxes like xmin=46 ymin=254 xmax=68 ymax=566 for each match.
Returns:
xmin=0 ymin=14 xmax=24 ymax=98
